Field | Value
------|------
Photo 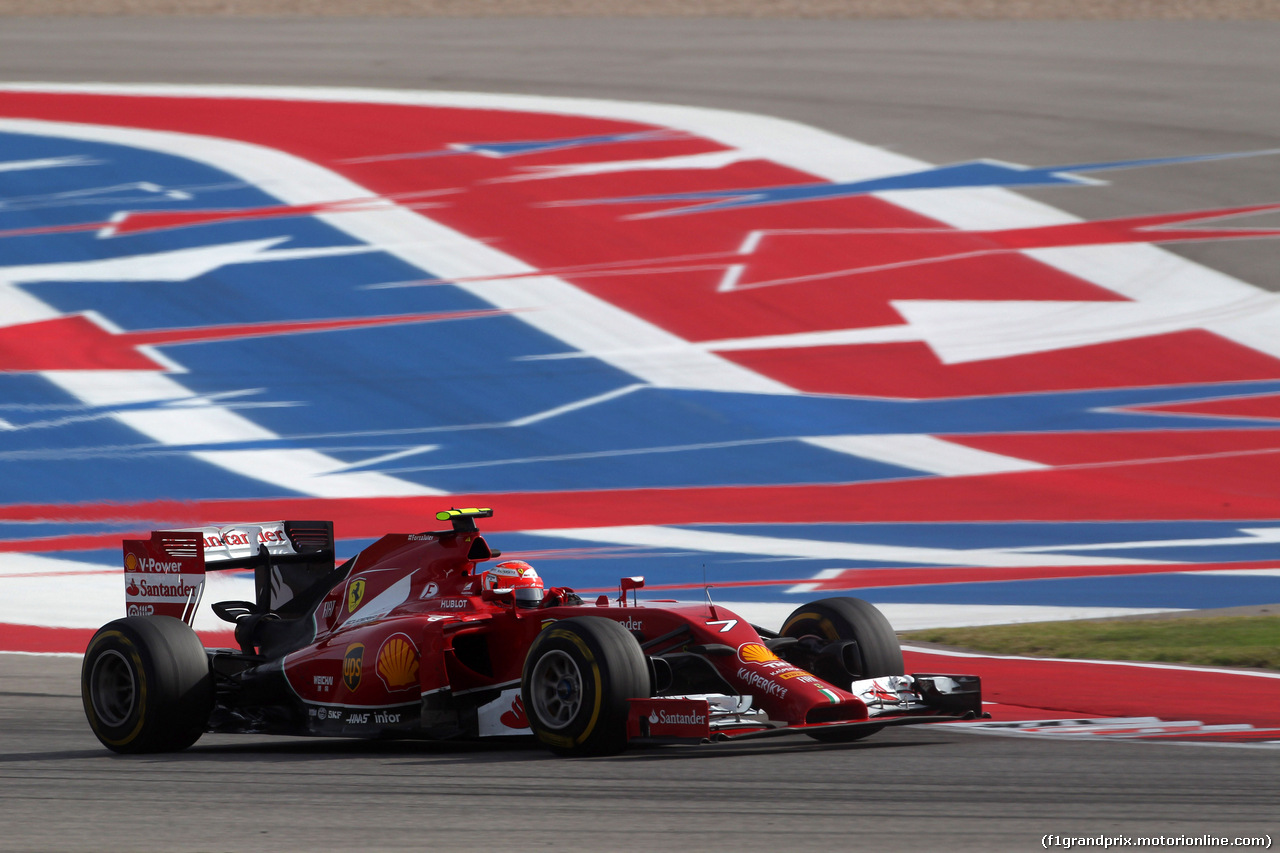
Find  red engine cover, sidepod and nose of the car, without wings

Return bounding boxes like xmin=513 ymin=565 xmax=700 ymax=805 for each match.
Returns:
xmin=277 ymin=533 xmax=868 ymax=729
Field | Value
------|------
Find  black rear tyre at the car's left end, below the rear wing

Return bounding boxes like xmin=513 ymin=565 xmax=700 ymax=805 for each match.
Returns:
xmin=81 ymin=616 xmax=214 ymax=753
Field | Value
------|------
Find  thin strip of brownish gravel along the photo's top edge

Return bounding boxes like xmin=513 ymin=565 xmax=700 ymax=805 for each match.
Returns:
xmin=0 ymin=0 xmax=1280 ymax=20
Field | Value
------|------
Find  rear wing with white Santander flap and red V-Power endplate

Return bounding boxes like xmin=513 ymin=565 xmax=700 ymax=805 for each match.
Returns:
xmin=123 ymin=521 xmax=334 ymax=624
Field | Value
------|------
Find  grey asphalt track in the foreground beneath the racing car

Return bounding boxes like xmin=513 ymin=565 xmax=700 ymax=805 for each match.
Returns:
xmin=0 ymin=656 xmax=1280 ymax=853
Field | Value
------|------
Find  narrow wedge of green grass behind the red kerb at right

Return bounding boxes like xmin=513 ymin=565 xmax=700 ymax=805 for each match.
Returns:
xmin=902 ymin=616 xmax=1280 ymax=670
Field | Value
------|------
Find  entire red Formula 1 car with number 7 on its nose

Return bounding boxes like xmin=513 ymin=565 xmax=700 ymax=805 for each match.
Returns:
xmin=81 ymin=510 xmax=982 ymax=756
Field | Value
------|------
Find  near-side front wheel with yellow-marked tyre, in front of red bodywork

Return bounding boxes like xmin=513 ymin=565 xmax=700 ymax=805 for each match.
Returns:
xmin=521 ymin=616 xmax=649 ymax=756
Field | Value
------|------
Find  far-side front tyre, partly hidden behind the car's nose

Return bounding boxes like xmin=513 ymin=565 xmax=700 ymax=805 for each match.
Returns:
xmin=782 ymin=598 xmax=906 ymax=743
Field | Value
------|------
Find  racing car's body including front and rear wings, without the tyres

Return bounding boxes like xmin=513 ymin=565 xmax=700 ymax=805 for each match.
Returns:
xmin=125 ymin=510 xmax=978 ymax=740
